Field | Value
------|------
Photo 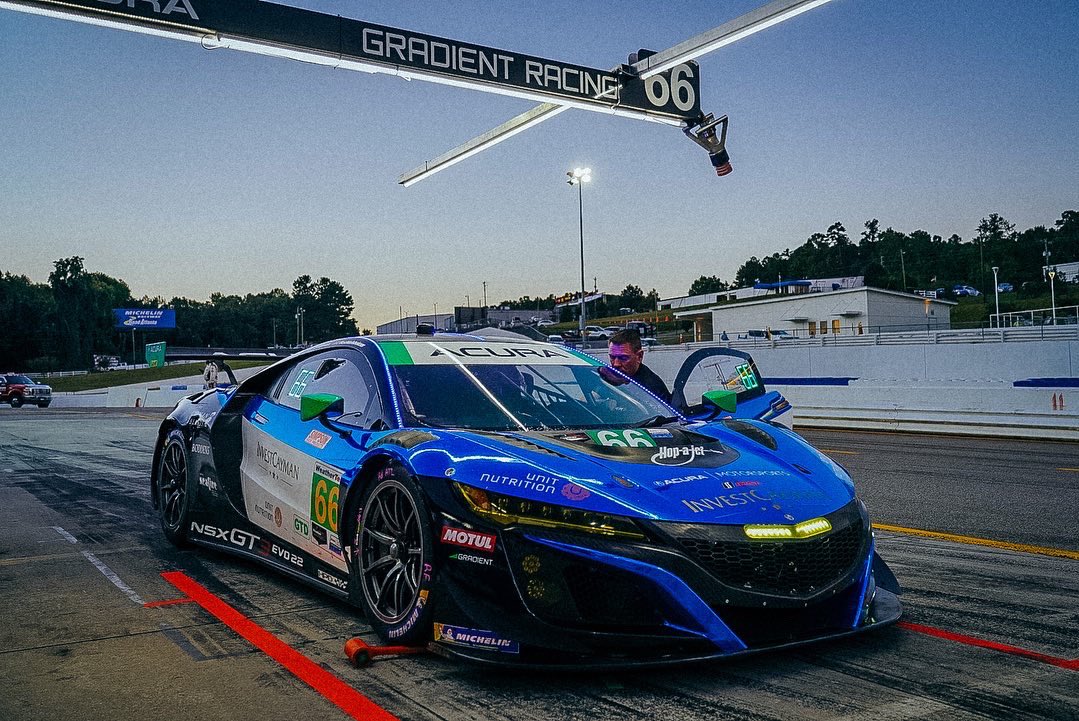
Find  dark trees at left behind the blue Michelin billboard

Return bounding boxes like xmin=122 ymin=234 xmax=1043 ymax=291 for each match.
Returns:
xmin=0 ymin=256 xmax=362 ymax=371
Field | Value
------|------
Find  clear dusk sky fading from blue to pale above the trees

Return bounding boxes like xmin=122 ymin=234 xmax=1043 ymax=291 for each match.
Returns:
xmin=0 ymin=0 xmax=1079 ymax=329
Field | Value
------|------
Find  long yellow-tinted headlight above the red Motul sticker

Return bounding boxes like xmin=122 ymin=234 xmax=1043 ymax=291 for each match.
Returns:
xmin=453 ymin=481 xmax=645 ymax=541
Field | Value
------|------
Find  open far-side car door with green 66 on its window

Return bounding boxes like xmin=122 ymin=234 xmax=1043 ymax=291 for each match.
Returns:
xmin=671 ymin=348 xmax=793 ymax=427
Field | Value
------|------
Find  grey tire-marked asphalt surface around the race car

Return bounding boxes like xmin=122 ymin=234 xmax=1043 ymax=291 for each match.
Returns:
xmin=0 ymin=408 xmax=1079 ymax=721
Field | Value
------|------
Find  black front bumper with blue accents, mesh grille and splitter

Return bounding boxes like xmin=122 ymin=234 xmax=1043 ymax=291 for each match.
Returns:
xmin=432 ymin=503 xmax=901 ymax=668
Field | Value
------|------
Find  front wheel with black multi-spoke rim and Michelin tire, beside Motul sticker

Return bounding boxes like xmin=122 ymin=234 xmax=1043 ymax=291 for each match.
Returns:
xmin=349 ymin=463 xmax=435 ymax=645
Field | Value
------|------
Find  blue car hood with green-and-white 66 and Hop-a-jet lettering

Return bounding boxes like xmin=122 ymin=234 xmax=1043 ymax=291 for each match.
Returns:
xmin=405 ymin=421 xmax=855 ymax=523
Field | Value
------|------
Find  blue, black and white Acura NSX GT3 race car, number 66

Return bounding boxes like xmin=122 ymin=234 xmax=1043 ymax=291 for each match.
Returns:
xmin=151 ymin=334 xmax=900 ymax=667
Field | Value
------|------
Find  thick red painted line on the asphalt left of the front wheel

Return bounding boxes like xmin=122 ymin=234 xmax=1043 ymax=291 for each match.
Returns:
xmin=161 ymin=571 xmax=398 ymax=721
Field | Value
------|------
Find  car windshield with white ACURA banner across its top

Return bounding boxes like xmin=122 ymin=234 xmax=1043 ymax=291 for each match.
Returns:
xmin=382 ymin=339 xmax=678 ymax=431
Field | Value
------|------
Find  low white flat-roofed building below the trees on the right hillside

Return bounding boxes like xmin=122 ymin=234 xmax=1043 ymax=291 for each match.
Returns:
xmin=674 ymin=286 xmax=956 ymax=340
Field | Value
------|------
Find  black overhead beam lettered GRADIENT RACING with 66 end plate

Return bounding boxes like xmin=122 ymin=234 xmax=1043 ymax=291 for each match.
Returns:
xmin=8 ymin=0 xmax=701 ymax=123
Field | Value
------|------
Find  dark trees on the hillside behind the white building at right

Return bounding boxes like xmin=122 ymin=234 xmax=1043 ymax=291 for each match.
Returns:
xmin=687 ymin=210 xmax=1079 ymax=296
